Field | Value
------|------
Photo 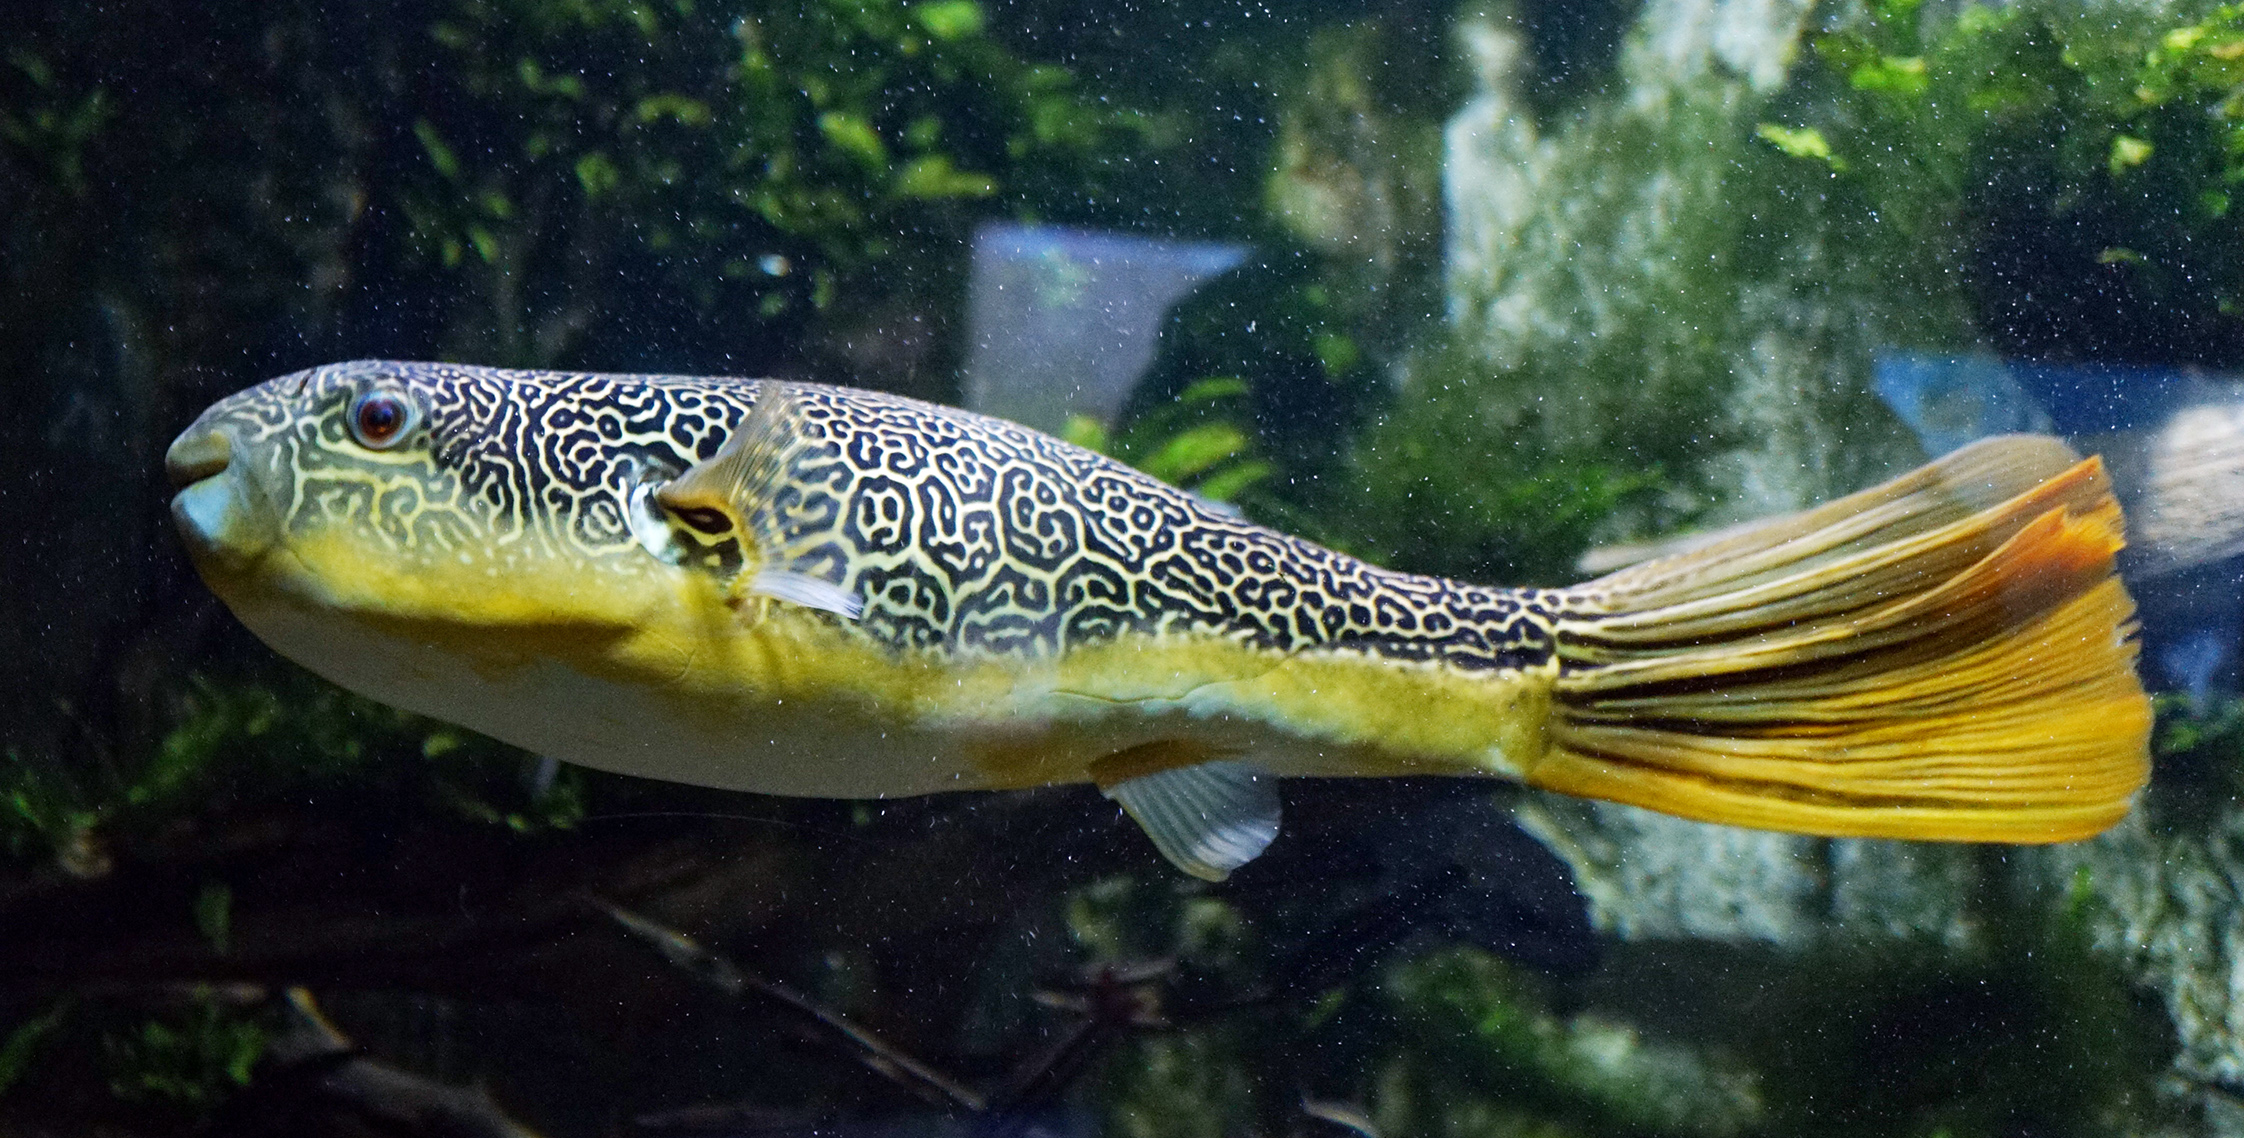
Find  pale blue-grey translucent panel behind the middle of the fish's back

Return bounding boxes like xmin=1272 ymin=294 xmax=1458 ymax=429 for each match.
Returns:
xmin=963 ymin=224 xmax=1248 ymax=431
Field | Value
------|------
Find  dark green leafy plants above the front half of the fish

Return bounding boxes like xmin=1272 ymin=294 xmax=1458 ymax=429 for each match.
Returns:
xmin=399 ymin=0 xmax=1144 ymax=359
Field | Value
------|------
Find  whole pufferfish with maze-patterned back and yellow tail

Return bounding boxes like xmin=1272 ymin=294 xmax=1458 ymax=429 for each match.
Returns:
xmin=166 ymin=361 xmax=2150 ymax=880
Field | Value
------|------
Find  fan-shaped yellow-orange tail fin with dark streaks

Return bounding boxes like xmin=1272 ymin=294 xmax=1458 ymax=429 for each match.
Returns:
xmin=1528 ymin=435 xmax=2150 ymax=842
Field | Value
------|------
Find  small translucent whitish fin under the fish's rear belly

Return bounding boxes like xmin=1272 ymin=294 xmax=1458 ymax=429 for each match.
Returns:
xmin=1100 ymin=759 xmax=1279 ymax=882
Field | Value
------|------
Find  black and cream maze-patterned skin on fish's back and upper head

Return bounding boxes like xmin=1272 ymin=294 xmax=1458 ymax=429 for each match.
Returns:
xmin=218 ymin=361 xmax=1569 ymax=671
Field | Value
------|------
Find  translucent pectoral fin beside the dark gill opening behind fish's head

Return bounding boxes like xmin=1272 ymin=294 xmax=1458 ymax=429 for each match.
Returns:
xmin=655 ymin=390 xmax=864 ymax=620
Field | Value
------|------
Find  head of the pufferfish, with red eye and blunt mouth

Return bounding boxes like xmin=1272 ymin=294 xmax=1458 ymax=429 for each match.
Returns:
xmin=166 ymin=361 xmax=736 ymax=673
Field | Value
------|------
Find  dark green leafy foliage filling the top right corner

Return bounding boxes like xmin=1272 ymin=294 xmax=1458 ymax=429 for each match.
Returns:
xmin=1762 ymin=0 xmax=2244 ymax=361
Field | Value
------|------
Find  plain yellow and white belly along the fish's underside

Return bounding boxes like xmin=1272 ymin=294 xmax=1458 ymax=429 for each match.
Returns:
xmin=227 ymin=527 xmax=1551 ymax=797
